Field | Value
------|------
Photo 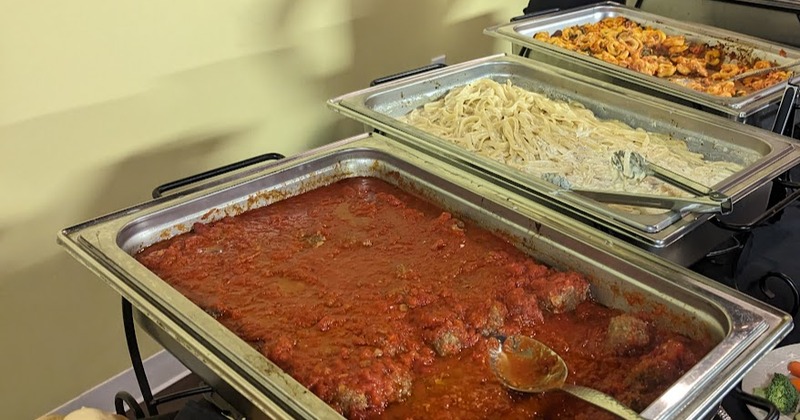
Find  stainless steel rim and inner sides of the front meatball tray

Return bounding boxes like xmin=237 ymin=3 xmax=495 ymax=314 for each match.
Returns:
xmin=58 ymin=135 xmax=791 ymax=418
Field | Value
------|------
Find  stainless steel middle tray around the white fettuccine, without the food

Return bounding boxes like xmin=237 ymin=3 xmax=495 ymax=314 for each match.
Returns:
xmin=329 ymin=55 xmax=800 ymax=265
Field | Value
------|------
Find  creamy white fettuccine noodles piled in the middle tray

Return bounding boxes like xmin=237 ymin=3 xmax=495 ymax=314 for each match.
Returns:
xmin=401 ymin=79 xmax=742 ymax=202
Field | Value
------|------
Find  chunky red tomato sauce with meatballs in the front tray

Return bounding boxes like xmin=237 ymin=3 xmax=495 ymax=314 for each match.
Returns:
xmin=136 ymin=177 xmax=713 ymax=419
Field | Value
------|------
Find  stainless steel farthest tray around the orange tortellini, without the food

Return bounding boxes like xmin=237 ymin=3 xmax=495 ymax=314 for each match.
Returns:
xmin=484 ymin=2 xmax=800 ymax=129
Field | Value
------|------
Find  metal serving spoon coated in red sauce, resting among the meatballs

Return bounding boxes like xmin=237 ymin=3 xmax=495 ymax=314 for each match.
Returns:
xmin=489 ymin=335 xmax=642 ymax=419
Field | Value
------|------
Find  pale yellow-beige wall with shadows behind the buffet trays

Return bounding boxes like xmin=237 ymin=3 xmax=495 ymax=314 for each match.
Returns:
xmin=0 ymin=0 xmax=523 ymax=419
